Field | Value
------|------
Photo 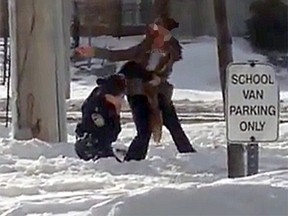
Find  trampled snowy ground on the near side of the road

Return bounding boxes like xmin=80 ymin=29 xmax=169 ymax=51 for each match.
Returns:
xmin=0 ymin=123 xmax=288 ymax=216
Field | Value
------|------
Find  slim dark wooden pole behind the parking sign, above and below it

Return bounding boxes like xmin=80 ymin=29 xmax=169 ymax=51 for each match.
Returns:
xmin=214 ymin=0 xmax=245 ymax=178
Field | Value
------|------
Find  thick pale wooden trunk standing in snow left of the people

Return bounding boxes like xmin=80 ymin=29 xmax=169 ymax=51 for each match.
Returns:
xmin=9 ymin=0 xmax=67 ymax=142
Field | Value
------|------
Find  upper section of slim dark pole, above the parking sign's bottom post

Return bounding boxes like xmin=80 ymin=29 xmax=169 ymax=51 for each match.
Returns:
xmin=214 ymin=0 xmax=233 ymax=104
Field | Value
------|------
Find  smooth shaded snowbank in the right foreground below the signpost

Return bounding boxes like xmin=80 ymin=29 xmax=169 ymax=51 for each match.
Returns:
xmin=99 ymin=171 xmax=288 ymax=216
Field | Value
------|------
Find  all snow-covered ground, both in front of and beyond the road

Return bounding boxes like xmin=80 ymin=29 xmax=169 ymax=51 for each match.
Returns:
xmin=0 ymin=37 xmax=288 ymax=216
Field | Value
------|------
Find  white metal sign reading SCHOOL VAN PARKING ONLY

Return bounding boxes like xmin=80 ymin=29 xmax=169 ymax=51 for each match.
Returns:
xmin=225 ymin=63 xmax=279 ymax=143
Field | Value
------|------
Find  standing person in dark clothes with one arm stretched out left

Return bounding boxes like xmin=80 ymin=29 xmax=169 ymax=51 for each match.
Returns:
xmin=77 ymin=18 xmax=196 ymax=161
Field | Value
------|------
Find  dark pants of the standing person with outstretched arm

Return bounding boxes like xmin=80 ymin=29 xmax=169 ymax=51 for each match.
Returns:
xmin=126 ymin=95 xmax=195 ymax=161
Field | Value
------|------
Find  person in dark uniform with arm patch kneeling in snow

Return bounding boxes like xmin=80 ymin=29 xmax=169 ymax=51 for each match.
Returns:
xmin=75 ymin=74 xmax=126 ymax=161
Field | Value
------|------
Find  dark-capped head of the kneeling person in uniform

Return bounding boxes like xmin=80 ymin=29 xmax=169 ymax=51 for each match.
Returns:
xmin=96 ymin=74 xmax=126 ymax=97
